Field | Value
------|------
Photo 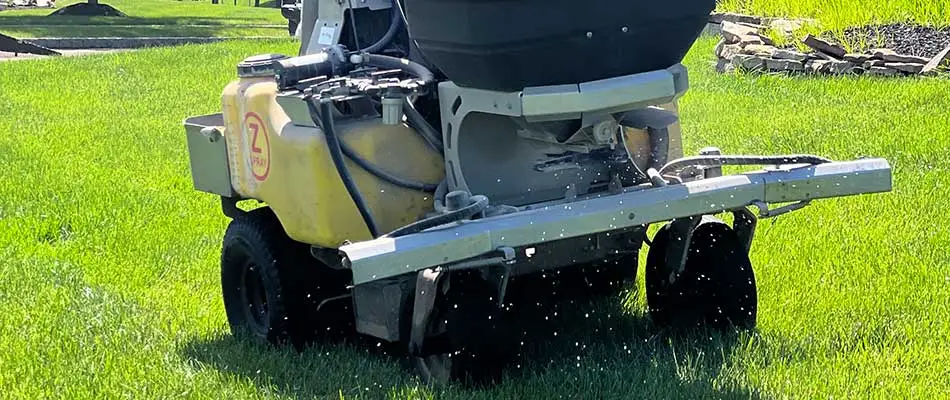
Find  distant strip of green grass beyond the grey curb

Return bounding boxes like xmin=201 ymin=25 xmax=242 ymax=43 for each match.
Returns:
xmin=0 ymin=0 xmax=288 ymax=37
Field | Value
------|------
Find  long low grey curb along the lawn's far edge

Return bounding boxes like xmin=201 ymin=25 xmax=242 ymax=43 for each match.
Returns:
xmin=20 ymin=36 xmax=291 ymax=50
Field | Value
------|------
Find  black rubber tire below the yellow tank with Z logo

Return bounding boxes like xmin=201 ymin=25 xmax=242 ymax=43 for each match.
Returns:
xmin=221 ymin=207 xmax=351 ymax=349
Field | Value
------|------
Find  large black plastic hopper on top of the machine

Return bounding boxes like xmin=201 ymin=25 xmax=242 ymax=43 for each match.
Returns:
xmin=403 ymin=0 xmax=716 ymax=91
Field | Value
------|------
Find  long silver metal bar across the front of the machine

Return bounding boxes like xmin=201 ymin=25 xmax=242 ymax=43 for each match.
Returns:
xmin=340 ymin=159 xmax=892 ymax=285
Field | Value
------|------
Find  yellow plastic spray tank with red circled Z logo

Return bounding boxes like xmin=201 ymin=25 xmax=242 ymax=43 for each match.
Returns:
xmin=214 ymin=55 xmax=444 ymax=248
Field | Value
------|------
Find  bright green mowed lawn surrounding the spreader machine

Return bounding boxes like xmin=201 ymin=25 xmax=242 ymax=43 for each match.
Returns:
xmin=0 ymin=39 xmax=950 ymax=399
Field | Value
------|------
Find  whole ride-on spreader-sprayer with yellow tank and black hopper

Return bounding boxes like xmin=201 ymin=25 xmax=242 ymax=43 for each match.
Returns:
xmin=185 ymin=0 xmax=892 ymax=381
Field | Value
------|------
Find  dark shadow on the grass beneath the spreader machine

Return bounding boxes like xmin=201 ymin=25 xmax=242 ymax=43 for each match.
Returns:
xmin=182 ymin=280 xmax=759 ymax=399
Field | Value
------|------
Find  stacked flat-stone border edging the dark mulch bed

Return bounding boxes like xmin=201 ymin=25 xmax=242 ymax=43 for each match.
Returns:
xmin=715 ymin=21 xmax=950 ymax=77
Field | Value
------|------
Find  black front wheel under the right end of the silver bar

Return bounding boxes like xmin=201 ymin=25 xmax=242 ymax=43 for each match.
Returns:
xmin=646 ymin=218 xmax=757 ymax=329
